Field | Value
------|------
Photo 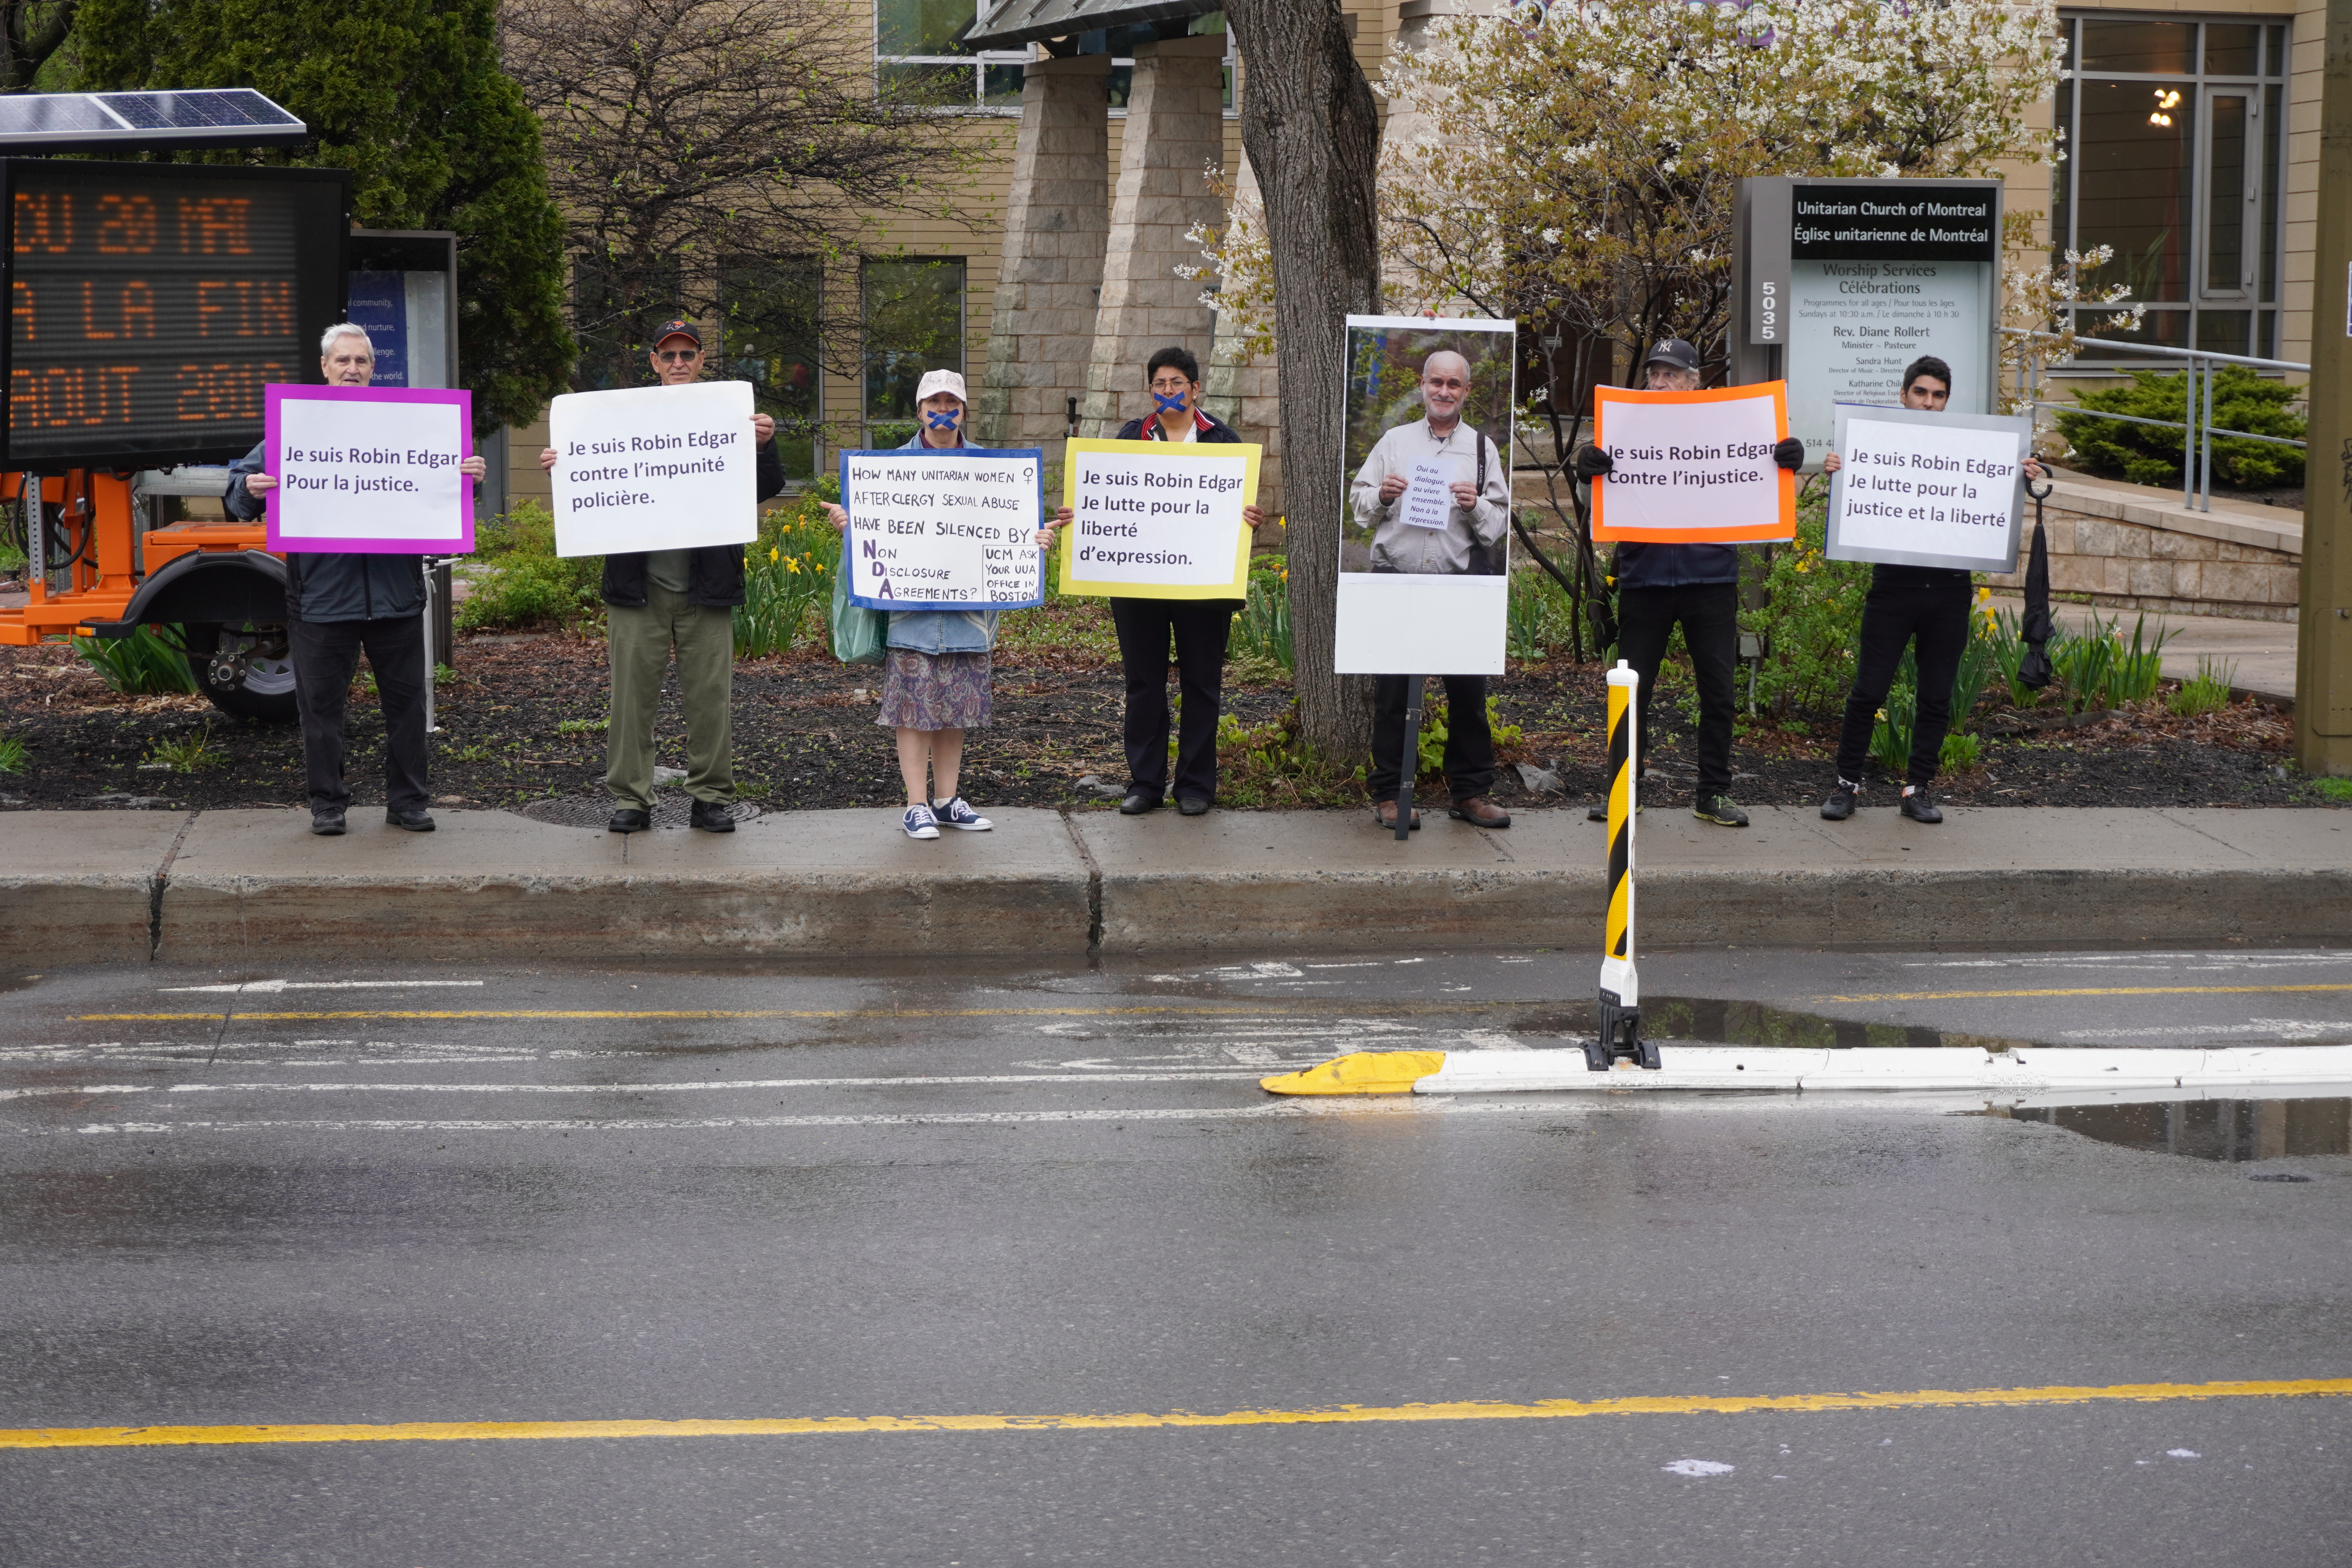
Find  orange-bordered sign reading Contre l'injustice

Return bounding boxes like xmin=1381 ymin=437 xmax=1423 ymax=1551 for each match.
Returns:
xmin=1592 ymin=381 xmax=1797 ymax=545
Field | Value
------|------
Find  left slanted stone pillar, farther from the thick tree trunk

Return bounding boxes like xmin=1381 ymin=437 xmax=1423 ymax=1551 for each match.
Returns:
xmin=971 ymin=54 xmax=1110 ymax=463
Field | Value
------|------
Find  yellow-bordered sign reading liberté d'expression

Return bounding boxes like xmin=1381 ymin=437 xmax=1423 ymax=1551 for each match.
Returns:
xmin=1061 ymin=437 xmax=1265 ymax=599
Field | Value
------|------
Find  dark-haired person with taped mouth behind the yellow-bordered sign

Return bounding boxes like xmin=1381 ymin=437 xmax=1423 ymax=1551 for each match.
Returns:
xmin=1054 ymin=346 xmax=1265 ymax=816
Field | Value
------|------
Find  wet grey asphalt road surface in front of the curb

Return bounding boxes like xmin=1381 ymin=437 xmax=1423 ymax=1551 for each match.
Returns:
xmin=0 ymin=952 xmax=2352 ymax=1568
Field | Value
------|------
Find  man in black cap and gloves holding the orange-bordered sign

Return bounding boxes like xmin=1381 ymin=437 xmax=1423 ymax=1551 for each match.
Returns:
xmin=1576 ymin=339 xmax=1804 ymax=828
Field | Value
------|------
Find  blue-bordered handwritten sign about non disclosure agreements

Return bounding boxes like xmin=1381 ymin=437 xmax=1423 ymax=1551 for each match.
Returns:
xmin=842 ymin=446 xmax=1044 ymax=609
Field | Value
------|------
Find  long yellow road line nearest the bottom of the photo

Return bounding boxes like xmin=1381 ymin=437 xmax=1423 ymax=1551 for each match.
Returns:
xmin=0 ymin=1377 xmax=2352 ymax=1448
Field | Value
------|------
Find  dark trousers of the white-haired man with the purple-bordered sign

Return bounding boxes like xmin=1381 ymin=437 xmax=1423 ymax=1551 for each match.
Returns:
xmin=287 ymin=616 xmax=428 ymax=811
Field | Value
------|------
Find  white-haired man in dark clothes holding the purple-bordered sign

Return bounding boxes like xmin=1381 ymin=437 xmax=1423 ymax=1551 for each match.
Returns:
xmin=223 ymin=322 xmax=489 ymax=835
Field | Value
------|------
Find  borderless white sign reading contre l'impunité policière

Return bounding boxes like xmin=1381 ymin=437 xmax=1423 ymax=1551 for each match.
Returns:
xmin=548 ymin=381 xmax=760 ymax=555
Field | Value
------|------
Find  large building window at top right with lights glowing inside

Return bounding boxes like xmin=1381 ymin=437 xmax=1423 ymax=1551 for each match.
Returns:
xmin=2051 ymin=12 xmax=2286 ymax=360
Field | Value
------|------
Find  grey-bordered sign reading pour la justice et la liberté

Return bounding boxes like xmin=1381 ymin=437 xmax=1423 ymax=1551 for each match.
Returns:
xmin=1825 ymin=402 xmax=2032 ymax=571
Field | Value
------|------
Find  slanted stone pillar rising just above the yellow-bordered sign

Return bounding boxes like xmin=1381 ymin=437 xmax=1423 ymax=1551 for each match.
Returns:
xmin=1080 ymin=35 xmax=1225 ymax=437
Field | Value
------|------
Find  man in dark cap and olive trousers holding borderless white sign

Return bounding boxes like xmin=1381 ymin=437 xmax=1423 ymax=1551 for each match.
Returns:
xmin=539 ymin=320 xmax=783 ymax=832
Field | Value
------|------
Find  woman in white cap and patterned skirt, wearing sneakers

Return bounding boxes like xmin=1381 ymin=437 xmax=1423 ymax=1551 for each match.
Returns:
xmin=826 ymin=369 xmax=1054 ymax=839
